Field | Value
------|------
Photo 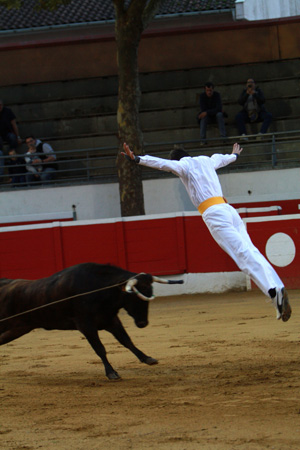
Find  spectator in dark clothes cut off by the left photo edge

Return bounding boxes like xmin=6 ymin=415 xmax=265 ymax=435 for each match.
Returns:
xmin=0 ymin=100 xmax=22 ymax=150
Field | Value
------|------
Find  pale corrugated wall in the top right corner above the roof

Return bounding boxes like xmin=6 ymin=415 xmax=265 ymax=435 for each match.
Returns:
xmin=235 ymin=0 xmax=300 ymax=20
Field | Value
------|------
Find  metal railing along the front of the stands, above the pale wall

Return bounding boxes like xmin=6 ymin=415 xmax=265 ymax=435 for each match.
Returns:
xmin=0 ymin=130 xmax=300 ymax=190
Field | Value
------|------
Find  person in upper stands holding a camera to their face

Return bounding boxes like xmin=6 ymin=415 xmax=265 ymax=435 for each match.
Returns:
xmin=235 ymin=78 xmax=272 ymax=139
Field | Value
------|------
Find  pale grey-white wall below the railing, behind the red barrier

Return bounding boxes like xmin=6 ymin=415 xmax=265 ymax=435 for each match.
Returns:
xmin=0 ymin=168 xmax=300 ymax=221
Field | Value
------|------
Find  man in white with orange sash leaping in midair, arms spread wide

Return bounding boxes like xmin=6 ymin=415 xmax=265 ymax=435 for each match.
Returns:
xmin=122 ymin=143 xmax=292 ymax=322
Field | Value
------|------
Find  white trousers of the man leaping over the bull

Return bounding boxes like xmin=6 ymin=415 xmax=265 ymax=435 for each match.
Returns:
xmin=202 ymin=203 xmax=283 ymax=297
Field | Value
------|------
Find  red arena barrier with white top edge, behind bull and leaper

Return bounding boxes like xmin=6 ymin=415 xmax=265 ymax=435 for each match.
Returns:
xmin=0 ymin=212 xmax=300 ymax=288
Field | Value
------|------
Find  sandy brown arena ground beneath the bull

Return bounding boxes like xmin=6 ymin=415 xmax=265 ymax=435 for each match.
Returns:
xmin=0 ymin=291 xmax=300 ymax=450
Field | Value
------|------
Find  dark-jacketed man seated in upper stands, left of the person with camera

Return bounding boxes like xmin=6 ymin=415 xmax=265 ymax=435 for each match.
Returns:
xmin=198 ymin=81 xmax=226 ymax=145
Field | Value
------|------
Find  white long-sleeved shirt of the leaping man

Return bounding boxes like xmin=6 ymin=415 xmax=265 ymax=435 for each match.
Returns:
xmin=139 ymin=153 xmax=237 ymax=208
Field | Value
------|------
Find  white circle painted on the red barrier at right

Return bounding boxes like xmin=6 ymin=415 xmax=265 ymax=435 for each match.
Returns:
xmin=266 ymin=233 xmax=296 ymax=267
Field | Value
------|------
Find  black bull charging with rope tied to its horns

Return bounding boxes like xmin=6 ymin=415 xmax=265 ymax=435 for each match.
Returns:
xmin=0 ymin=263 xmax=182 ymax=380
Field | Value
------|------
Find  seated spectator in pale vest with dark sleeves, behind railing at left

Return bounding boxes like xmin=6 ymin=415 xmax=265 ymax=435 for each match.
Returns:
xmin=25 ymin=136 xmax=57 ymax=184
